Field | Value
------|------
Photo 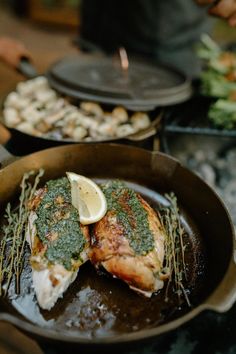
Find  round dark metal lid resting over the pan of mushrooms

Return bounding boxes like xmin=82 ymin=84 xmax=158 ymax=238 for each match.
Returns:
xmin=48 ymin=55 xmax=192 ymax=109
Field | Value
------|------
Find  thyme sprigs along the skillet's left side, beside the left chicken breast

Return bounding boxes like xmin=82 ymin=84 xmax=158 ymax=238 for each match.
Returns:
xmin=0 ymin=169 xmax=44 ymax=296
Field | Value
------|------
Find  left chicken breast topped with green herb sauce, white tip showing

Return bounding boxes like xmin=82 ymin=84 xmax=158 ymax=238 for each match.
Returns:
xmin=26 ymin=177 xmax=90 ymax=310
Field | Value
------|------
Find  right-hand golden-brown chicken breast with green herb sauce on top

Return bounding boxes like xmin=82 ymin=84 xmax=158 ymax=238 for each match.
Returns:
xmin=90 ymin=181 xmax=165 ymax=297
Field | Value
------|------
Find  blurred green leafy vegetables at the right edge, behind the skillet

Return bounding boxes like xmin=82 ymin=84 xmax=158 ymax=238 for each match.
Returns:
xmin=197 ymin=35 xmax=236 ymax=129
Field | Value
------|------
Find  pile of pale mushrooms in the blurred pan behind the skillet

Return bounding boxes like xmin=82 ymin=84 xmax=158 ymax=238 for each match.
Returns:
xmin=3 ymin=76 xmax=151 ymax=141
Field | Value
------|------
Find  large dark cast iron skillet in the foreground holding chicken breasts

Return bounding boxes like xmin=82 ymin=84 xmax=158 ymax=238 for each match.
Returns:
xmin=0 ymin=144 xmax=236 ymax=350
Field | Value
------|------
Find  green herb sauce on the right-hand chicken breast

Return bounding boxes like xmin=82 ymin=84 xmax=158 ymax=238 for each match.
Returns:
xmin=101 ymin=180 xmax=154 ymax=255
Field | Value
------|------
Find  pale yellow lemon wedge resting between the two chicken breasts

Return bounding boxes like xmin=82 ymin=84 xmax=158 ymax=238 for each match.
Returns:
xmin=66 ymin=172 xmax=107 ymax=225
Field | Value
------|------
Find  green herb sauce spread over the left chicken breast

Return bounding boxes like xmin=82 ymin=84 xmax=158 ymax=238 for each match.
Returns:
xmin=35 ymin=177 xmax=86 ymax=270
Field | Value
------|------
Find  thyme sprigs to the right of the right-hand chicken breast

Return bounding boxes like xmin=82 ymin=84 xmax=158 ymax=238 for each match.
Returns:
xmin=160 ymin=192 xmax=191 ymax=306
